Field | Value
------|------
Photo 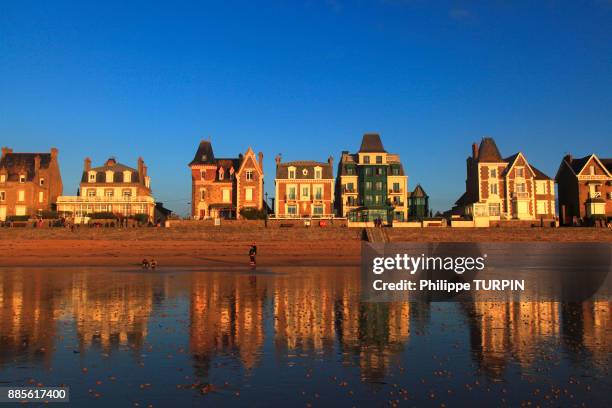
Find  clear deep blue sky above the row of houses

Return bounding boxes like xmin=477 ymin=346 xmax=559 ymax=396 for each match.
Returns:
xmin=0 ymin=0 xmax=612 ymax=217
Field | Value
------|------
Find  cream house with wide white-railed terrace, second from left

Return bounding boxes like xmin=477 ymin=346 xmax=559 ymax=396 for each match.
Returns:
xmin=57 ymin=157 xmax=155 ymax=223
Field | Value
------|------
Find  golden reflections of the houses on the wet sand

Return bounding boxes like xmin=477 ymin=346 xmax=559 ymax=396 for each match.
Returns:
xmin=0 ymin=268 xmax=612 ymax=388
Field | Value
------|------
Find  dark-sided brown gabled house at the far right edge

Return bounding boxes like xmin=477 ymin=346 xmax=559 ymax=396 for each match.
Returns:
xmin=555 ymin=154 xmax=612 ymax=225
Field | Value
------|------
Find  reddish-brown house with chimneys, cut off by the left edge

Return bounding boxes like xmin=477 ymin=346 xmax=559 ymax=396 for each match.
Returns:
xmin=0 ymin=147 xmax=63 ymax=221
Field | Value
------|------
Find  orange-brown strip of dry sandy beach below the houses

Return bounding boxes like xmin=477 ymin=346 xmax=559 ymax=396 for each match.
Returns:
xmin=0 ymin=224 xmax=612 ymax=267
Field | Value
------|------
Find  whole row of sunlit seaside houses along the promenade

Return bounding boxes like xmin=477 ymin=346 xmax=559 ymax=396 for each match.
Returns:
xmin=0 ymin=133 xmax=612 ymax=225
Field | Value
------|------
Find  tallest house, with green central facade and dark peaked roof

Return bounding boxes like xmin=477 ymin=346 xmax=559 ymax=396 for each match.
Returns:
xmin=336 ymin=133 xmax=408 ymax=223
